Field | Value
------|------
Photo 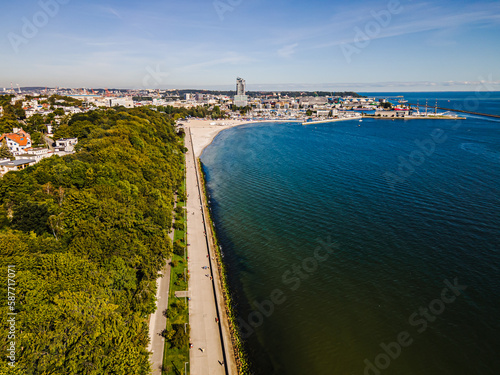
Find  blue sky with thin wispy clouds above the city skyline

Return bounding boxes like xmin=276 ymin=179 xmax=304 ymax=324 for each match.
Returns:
xmin=0 ymin=0 xmax=500 ymax=92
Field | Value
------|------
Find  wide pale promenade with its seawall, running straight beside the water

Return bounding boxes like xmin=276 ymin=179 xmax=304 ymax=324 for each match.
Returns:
xmin=185 ymin=125 xmax=237 ymax=375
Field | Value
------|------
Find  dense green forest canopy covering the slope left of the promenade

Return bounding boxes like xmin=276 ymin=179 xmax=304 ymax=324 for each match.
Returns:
xmin=0 ymin=108 xmax=185 ymax=375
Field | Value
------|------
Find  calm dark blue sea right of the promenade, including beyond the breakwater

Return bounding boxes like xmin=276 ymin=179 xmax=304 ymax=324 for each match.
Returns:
xmin=202 ymin=93 xmax=500 ymax=375
